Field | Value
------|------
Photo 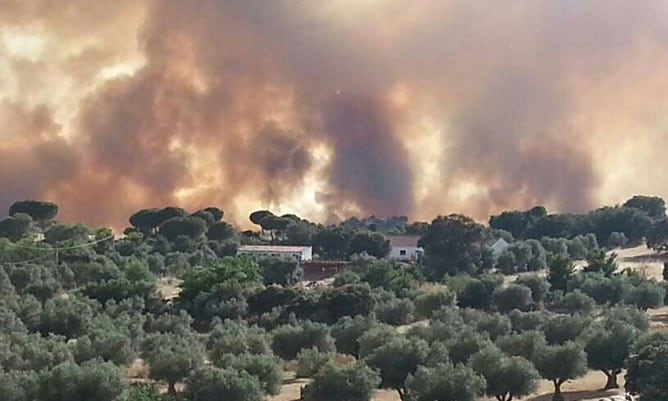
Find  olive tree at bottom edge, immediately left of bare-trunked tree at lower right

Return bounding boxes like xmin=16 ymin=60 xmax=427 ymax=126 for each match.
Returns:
xmin=470 ymin=347 xmax=540 ymax=401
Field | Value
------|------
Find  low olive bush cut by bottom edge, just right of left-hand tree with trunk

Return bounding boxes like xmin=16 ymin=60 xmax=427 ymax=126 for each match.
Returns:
xmin=184 ymin=367 xmax=263 ymax=401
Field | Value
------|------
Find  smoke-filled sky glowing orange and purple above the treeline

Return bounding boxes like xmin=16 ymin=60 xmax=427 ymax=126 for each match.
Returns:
xmin=0 ymin=0 xmax=668 ymax=227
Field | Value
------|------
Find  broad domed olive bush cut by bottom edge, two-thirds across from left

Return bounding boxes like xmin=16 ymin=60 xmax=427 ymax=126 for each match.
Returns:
xmin=406 ymin=363 xmax=486 ymax=401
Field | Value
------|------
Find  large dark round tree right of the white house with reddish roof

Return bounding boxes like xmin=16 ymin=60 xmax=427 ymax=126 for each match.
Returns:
xmin=418 ymin=214 xmax=485 ymax=281
